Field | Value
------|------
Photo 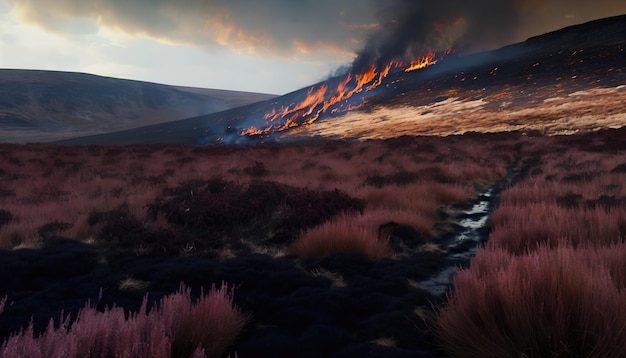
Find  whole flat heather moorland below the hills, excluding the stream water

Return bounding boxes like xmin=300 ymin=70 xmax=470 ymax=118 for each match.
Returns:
xmin=0 ymin=129 xmax=626 ymax=357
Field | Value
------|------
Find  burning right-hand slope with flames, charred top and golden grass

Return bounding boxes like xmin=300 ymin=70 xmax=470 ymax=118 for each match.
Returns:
xmin=234 ymin=17 xmax=626 ymax=140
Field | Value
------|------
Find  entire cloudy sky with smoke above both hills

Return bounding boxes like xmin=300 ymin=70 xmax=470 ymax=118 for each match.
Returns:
xmin=0 ymin=0 xmax=626 ymax=94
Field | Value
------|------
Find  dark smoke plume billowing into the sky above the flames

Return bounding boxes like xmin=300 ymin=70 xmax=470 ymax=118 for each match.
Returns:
xmin=352 ymin=0 xmax=519 ymax=71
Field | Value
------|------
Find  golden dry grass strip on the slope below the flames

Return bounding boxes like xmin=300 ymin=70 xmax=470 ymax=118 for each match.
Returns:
xmin=289 ymin=86 xmax=626 ymax=139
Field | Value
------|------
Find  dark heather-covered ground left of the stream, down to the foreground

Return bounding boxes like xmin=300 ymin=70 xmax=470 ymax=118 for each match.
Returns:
xmin=0 ymin=136 xmax=513 ymax=357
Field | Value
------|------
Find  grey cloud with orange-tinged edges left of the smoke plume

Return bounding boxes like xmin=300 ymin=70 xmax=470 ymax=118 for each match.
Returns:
xmin=7 ymin=0 xmax=376 ymax=61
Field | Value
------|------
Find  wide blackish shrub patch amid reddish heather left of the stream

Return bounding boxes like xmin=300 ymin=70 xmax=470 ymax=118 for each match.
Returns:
xmin=148 ymin=178 xmax=364 ymax=242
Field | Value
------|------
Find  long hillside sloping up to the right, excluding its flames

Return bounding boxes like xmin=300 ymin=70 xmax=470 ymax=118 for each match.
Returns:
xmin=56 ymin=16 xmax=626 ymax=144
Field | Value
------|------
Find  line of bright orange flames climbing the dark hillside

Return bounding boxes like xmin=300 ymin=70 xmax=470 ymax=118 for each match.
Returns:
xmin=240 ymin=50 xmax=452 ymax=136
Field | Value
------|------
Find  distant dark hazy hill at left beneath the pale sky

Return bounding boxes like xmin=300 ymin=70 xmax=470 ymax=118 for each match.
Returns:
xmin=0 ymin=69 xmax=275 ymax=142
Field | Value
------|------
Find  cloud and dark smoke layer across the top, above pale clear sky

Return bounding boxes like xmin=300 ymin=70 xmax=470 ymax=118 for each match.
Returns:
xmin=5 ymin=0 xmax=626 ymax=66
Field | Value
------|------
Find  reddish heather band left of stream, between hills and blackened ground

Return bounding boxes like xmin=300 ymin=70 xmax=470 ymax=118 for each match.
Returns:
xmin=0 ymin=138 xmax=506 ymax=252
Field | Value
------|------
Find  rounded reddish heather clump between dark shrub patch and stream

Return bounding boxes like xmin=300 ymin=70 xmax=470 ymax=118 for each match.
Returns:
xmin=289 ymin=216 xmax=389 ymax=260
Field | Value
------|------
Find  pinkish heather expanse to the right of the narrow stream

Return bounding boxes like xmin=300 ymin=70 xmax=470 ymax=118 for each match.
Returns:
xmin=436 ymin=132 xmax=626 ymax=357
